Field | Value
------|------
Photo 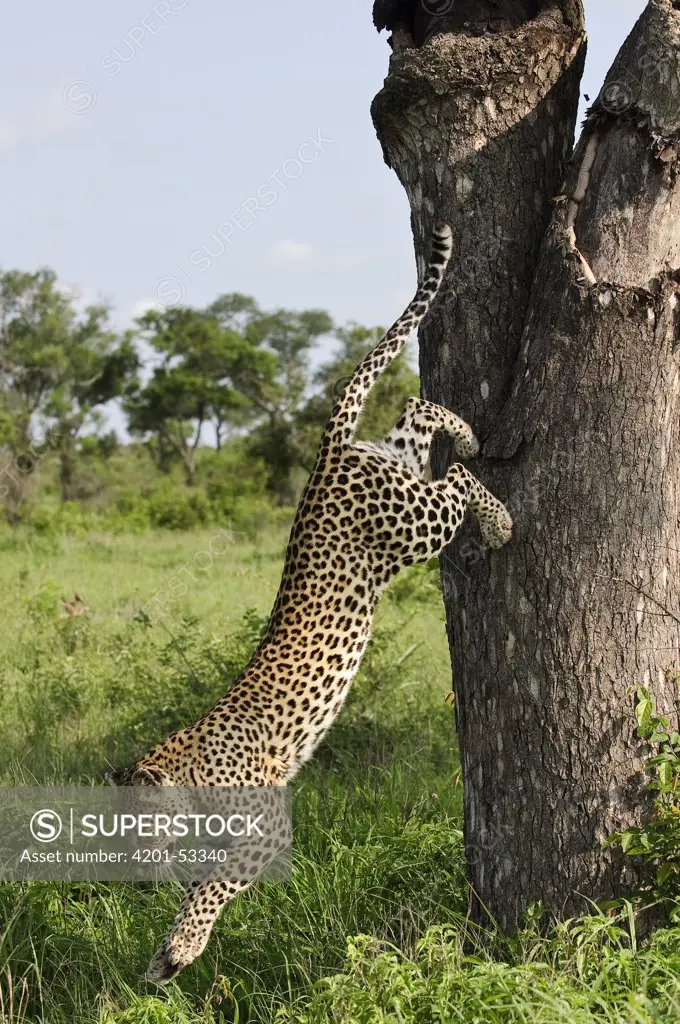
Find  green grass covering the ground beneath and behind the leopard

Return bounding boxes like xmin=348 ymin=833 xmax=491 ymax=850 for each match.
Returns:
xmin=0 ymin=529 xmax=680 ymax=1024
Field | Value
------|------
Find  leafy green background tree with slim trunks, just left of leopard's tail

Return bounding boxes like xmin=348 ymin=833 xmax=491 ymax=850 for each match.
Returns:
xmin=126 ymin=293 xmax=333 ymax=501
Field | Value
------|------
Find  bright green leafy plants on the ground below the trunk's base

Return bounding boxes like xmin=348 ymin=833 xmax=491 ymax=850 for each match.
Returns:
xmin=278 ymin=915 xmax=680 ymax=1024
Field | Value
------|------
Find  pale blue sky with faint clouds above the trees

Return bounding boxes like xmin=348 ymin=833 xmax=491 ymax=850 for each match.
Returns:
xmin=0 ymin=0 xmax=644 ymax=325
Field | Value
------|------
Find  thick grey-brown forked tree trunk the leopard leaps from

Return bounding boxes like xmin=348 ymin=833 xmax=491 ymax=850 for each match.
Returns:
xmin=374 ymin=0 xmax=680 ymax=929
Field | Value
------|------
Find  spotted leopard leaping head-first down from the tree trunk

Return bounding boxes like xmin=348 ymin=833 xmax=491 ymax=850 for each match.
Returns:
xmin=112 ymin=223 xmax=513 ymax=984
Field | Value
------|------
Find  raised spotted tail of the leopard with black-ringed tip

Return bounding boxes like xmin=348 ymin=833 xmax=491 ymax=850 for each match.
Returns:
xmin=322 ymin=223 xmax=452 ymax=452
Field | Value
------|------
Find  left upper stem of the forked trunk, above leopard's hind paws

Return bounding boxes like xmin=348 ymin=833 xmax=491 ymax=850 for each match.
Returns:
xmin=372 ymin=0 xmax=586 ymax=438
